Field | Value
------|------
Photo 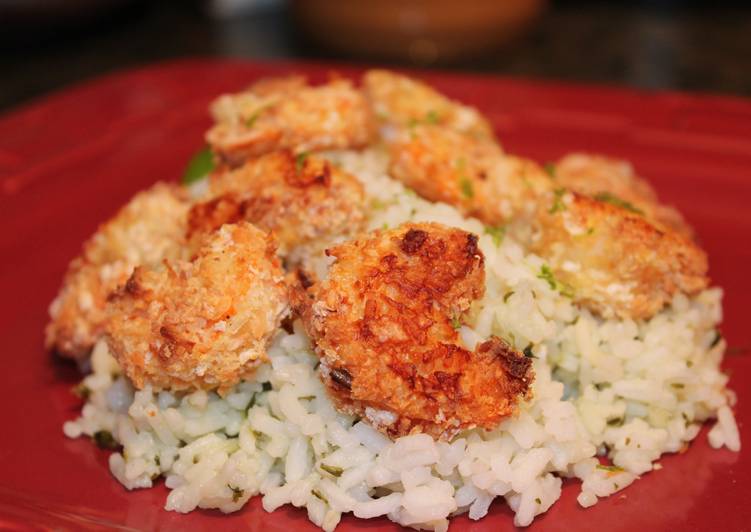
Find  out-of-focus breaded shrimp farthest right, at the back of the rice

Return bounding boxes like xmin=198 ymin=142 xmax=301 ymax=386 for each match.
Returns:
xmin=553 ymin=153 xmax=693 ymax=238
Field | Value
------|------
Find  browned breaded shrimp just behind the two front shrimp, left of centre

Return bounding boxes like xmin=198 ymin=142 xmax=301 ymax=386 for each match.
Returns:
xmin=189 ymin=150 xmax=364 ymax=255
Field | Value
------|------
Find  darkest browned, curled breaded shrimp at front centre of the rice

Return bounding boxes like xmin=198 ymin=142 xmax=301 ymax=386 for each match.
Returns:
xmin=294 ymin=223 xmax=533 ymax=438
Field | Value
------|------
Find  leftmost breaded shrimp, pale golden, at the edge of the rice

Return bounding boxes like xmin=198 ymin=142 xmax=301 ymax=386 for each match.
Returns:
xmin=45 ymin=183 xmax=188 ymax=359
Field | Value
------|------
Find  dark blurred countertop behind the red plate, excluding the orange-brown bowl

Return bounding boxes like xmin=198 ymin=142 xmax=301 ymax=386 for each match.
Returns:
xmin=0 ymin=1 xmax=751 ymax=111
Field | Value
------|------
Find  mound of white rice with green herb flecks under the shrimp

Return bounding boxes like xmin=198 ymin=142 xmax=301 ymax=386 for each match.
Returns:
xmin=64 ymin=151 xmax=740 ymax=530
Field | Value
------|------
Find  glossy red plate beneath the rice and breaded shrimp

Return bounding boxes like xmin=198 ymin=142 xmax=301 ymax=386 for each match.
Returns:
xmin=0 ymin=60 xmax=751 ymax=531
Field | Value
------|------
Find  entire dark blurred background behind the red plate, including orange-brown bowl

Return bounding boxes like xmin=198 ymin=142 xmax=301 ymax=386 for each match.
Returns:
xmin=0 ymin=0 xmax=751 ymax=112
